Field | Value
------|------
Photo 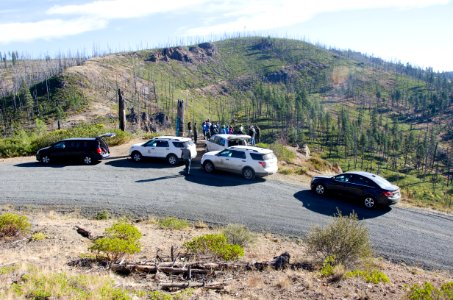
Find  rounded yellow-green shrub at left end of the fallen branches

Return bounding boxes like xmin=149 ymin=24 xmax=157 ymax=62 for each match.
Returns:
xmin=89 ymin=221 xmax=142 ymax=261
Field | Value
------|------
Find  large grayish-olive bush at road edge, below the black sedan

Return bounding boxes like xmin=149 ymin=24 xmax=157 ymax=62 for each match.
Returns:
xmin=306 ymin=212 xmax=372 ymax=266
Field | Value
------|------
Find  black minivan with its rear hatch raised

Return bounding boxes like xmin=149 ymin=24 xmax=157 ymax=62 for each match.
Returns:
xmin=36 ymin=133 xmax=115 ymax=165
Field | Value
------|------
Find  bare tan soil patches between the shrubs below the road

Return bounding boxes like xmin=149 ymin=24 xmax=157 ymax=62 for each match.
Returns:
xmin=0 ymin=212 xmax=453 ymax=299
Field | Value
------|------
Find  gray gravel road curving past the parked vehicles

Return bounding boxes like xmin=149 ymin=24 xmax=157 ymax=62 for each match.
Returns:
xmin=0 ymin=157 xmax=453 ymax=271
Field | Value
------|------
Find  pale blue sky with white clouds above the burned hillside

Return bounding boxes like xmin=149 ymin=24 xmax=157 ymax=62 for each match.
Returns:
xmin=0 ymin=0 xmax=453 ymax=72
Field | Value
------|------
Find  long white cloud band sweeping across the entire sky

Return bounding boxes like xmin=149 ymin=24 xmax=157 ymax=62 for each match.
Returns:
xmin=0 ymin=0 xmax=450 ymax=44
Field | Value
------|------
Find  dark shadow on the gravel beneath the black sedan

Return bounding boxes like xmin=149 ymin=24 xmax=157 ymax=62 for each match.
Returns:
xmin=294 ymin=190 xmax=392 ymax=220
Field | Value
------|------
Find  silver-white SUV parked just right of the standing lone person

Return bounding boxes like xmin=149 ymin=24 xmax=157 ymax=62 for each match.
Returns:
xmin=201 ymin=146 xmax=278 ymax=179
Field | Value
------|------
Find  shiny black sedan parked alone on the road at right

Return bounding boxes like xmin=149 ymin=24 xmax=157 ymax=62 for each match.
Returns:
xmin=311 ymin=171 xmax=401 ymax=209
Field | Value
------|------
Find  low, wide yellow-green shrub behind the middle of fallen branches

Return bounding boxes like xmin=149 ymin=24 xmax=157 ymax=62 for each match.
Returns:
xmin=184 ymin=234 xmax=244 ymax=260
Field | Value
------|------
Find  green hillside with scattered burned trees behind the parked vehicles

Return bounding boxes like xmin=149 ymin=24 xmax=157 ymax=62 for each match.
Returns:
xmin=0 ymin=37 xmax=453 ymax=208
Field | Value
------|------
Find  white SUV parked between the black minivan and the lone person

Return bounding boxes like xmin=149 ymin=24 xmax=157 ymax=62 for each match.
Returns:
xmin=129 ymin=136 xmax=197 ymax=166
